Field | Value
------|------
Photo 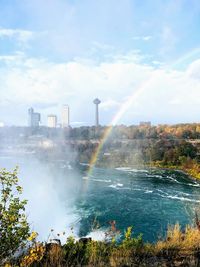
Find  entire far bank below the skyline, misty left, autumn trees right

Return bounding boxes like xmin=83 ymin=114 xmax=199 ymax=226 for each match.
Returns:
xmin=0 ymin=123 xmax=200 ymax=178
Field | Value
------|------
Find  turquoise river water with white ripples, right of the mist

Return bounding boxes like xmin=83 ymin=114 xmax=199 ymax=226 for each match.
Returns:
xmin=77 ymin=165 xmax=200 ymax=241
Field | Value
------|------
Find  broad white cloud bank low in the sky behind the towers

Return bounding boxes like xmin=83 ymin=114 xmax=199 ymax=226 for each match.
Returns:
xmin=0 ymin=52 xmax=200 ymax=125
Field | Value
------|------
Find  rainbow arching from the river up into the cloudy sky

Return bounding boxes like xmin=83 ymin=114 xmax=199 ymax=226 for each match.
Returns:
xmin=88 ymin=48 xmax=200 ymax=177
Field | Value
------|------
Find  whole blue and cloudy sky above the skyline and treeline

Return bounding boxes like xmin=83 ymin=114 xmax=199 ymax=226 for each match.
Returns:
xmin=0 ymin=0 xmax=200 ymax=127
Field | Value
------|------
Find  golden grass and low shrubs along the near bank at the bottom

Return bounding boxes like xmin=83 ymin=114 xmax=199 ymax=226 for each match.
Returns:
xmin=7 ymin=224 xmax=200 ymax=267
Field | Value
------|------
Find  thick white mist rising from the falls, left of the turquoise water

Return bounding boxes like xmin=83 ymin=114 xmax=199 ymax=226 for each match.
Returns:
xmin=0 ymin=130 xmax=81 ymax=241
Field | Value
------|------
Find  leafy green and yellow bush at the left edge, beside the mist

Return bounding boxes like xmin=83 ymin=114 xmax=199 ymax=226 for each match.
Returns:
xmin=0 ymin=168 xmax=30 ymax=266
